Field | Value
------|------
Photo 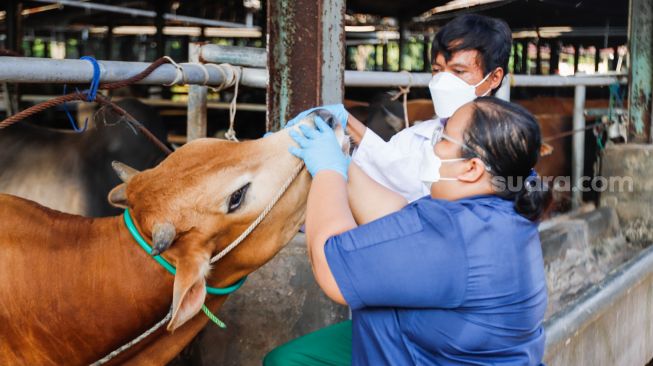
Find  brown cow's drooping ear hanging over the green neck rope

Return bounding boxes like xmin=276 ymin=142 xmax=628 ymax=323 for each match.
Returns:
xmin=168 ymin=253 xmax=209 ymax=332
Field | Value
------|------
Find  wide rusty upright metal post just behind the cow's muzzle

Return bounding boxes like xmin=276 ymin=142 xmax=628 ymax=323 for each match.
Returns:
xmin=267 ymin=0 xmax=344 ymax=130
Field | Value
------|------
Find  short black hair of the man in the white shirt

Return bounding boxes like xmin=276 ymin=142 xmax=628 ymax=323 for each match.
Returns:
xmin=431 ymin=14 xmax=512 ymax=90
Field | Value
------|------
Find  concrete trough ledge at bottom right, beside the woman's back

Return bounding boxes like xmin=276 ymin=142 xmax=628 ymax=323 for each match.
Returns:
xmin=544 ymin=242 xmax=653 ymax=366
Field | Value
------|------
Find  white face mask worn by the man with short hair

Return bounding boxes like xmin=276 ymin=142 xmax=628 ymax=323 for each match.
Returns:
xmin=429 ymin=71 xmax=491 ymax=118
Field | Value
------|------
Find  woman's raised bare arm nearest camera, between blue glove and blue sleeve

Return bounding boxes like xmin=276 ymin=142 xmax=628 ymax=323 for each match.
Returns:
xmin=306 ymin=170 xmax=356 ymax=304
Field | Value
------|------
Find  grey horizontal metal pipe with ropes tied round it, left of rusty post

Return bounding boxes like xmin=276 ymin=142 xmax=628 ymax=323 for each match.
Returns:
xmin=0 ymin=57 xmax=267 ymax=88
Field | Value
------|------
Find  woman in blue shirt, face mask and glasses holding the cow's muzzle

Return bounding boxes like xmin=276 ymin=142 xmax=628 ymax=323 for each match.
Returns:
xmin=264 ymin=98 xmax=550 ymax=366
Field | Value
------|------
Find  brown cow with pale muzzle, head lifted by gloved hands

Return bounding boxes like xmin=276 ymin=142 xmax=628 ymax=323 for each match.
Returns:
xmin=0 ymin=113 xmax=346 ymax=365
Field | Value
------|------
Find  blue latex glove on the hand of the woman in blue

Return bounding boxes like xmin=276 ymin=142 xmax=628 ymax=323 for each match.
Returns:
xmin=288 ymin=116 xmax=351 ymax=180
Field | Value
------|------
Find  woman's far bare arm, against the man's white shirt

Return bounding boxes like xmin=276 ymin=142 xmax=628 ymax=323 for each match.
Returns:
xmin=347 ymin=162 xmax=408 ymax=225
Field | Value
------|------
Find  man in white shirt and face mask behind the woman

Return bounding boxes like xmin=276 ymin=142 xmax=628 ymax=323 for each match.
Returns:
xmin=288 ymin=14 xmax=512 ymax=202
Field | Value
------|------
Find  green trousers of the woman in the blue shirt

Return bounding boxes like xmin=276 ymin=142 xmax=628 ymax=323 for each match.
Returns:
xmin=263 ymin=320 xmax=351 ymax=366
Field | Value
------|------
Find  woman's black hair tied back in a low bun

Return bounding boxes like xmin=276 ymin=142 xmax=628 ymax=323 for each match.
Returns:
xmin=462 ymin=97 xmax=551 ymax=220
